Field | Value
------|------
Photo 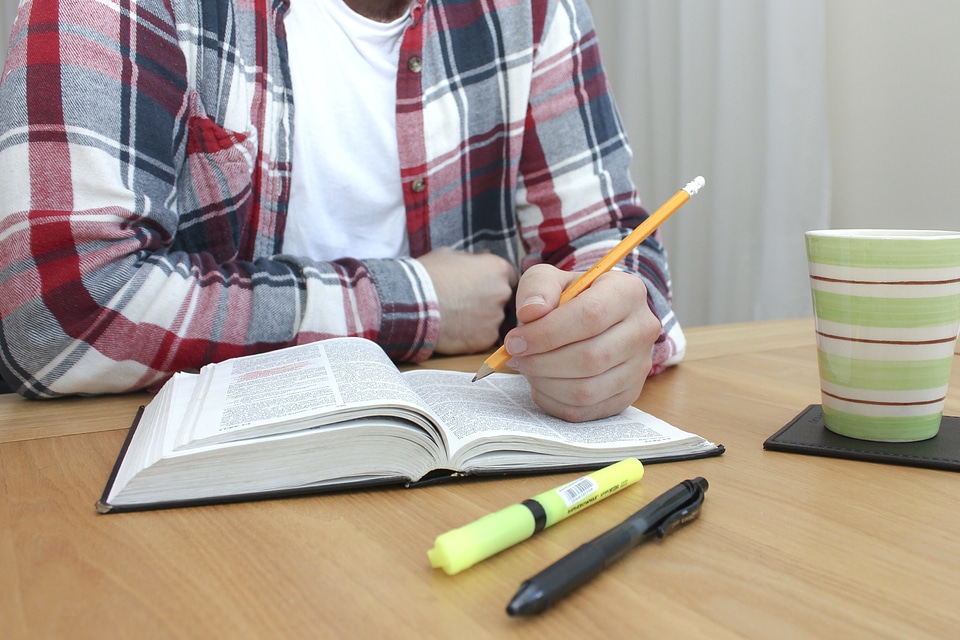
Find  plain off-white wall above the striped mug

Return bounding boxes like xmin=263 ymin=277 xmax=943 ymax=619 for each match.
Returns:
xmin=826 ymin=0 xmax=960 ymax=230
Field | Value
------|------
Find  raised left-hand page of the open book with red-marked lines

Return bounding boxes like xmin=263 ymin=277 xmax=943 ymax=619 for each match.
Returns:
xmin=177 ymin=338 xmax=436 ymax=448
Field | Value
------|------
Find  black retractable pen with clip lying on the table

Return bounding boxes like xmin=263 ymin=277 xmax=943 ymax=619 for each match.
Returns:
xmin=507 ymin=478 xmax=709 ymax=616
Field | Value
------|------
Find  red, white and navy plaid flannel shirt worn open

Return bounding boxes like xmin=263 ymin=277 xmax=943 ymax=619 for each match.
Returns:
xmin=0 ymin=0 xmax=683 ymax=397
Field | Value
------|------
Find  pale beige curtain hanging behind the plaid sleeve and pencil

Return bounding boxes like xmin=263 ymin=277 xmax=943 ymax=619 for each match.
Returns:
xmin=588 ymin=0 xmax=830 ymax=326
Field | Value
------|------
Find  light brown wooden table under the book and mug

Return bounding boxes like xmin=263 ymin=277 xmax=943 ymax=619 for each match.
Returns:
xmin=0 ymin=320 xmax=960 ymax=639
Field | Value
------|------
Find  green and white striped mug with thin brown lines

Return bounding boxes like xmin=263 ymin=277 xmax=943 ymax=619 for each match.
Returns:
xmin=806 ymin=229 xmax=960 ymax=442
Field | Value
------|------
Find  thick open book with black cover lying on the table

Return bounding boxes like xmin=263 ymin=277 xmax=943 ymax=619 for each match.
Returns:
xmin=97 ymin=338 xmax=723 ymax=513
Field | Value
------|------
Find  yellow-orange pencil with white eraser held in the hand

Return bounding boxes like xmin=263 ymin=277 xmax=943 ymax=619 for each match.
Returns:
xmin=473 ymin=176 xmax=706 ymax=382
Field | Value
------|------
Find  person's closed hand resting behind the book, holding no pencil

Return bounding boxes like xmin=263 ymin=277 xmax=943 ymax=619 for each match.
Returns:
xmin=419 ymin=247 xmax=517 ymax=355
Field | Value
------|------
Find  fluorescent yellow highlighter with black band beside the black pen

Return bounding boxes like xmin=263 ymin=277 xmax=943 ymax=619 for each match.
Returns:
xmin=427 ymin=458 xmax=643 ymax=575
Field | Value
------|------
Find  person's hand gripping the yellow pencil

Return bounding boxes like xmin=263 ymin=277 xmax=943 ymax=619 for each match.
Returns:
xmin=505 ymin=265 xmax=660 ymax=422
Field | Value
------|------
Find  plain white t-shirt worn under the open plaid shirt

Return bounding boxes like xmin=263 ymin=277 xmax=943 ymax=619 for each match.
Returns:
xmin=283 ymin=0 xmax=409 ymax=260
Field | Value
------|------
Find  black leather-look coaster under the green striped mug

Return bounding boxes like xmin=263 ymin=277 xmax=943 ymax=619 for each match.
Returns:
xmin=763 ymin=404 xmax=960 ymax=471
